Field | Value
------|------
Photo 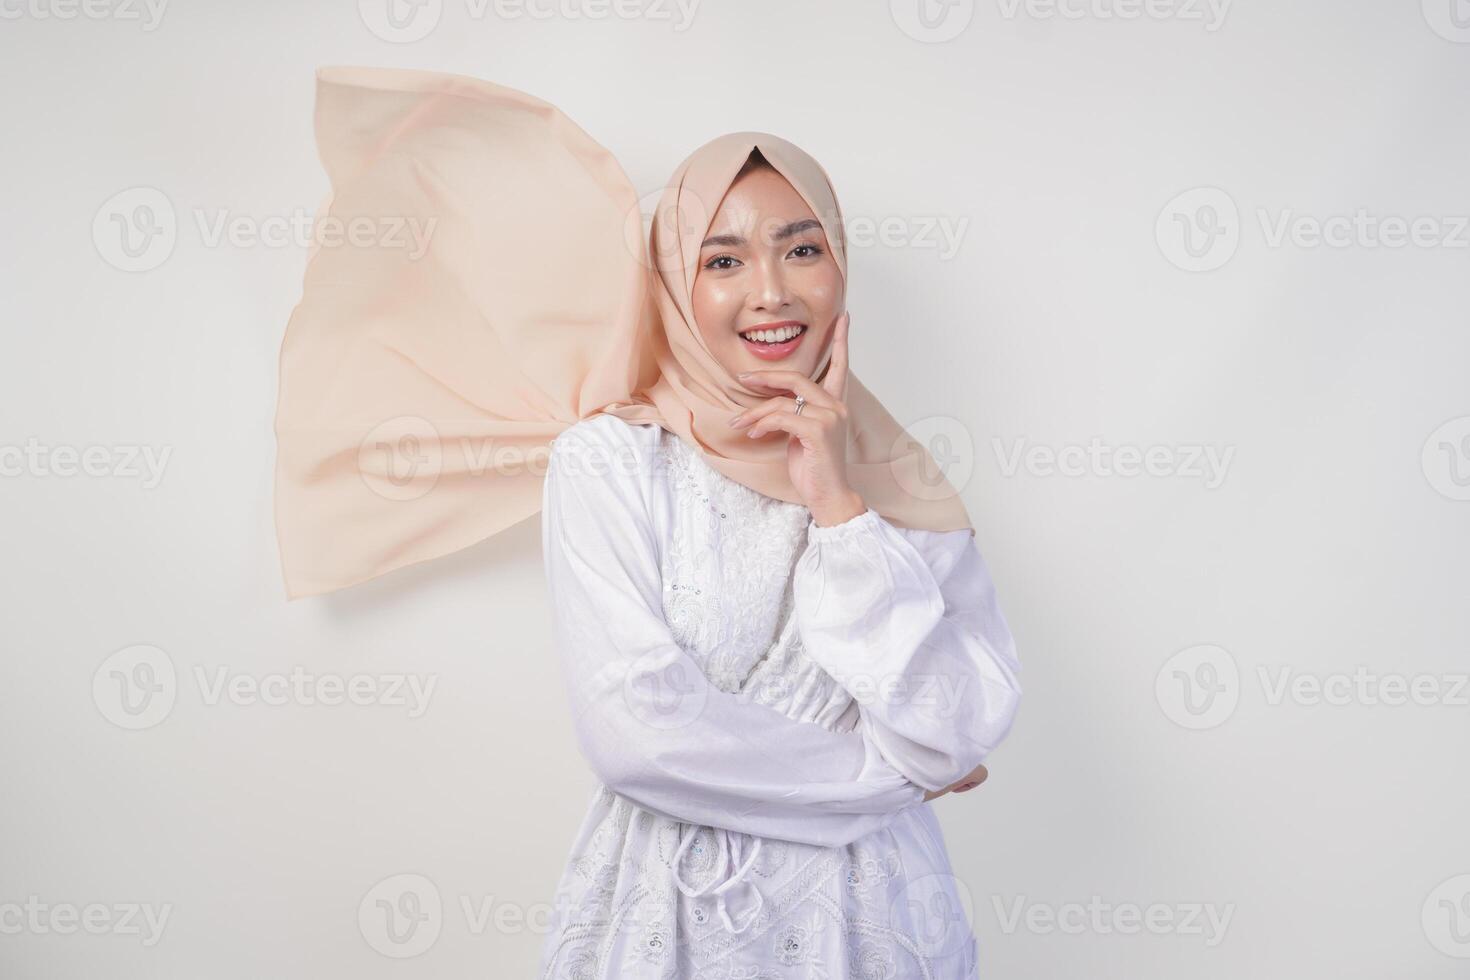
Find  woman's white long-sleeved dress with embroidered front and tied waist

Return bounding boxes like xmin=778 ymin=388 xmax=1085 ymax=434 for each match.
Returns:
xmin=539 ymin=414 xmax=1020 ymax=980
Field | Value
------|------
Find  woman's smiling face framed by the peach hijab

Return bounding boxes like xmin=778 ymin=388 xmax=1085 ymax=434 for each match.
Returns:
xmin=694 ymin=167 xmax=844 ymax=378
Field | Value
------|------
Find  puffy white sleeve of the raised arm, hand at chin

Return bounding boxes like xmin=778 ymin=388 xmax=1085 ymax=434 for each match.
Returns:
xmin=792 ymin=508 xmax=1022 ymax=789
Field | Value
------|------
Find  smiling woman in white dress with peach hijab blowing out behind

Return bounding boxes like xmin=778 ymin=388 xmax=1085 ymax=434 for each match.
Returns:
xmin=278 ymin=69 xmax=1020 ymax=980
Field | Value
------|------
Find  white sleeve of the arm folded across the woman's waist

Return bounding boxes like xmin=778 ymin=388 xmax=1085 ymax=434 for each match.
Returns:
xmin=542 ymin=416 xmax=923 ymax=846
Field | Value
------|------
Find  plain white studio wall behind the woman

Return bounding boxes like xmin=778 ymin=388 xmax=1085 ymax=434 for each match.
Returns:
xmin=0 ymin=0 xmax=1470 ymax=980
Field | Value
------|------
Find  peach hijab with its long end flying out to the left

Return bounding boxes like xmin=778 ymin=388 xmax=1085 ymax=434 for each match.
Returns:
xmin=275 ymin=68 xmax=973 ymax=599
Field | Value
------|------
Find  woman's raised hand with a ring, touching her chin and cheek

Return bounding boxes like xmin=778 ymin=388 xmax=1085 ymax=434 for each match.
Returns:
xmin=731 ymin=313 xmax=867 ymax=527
